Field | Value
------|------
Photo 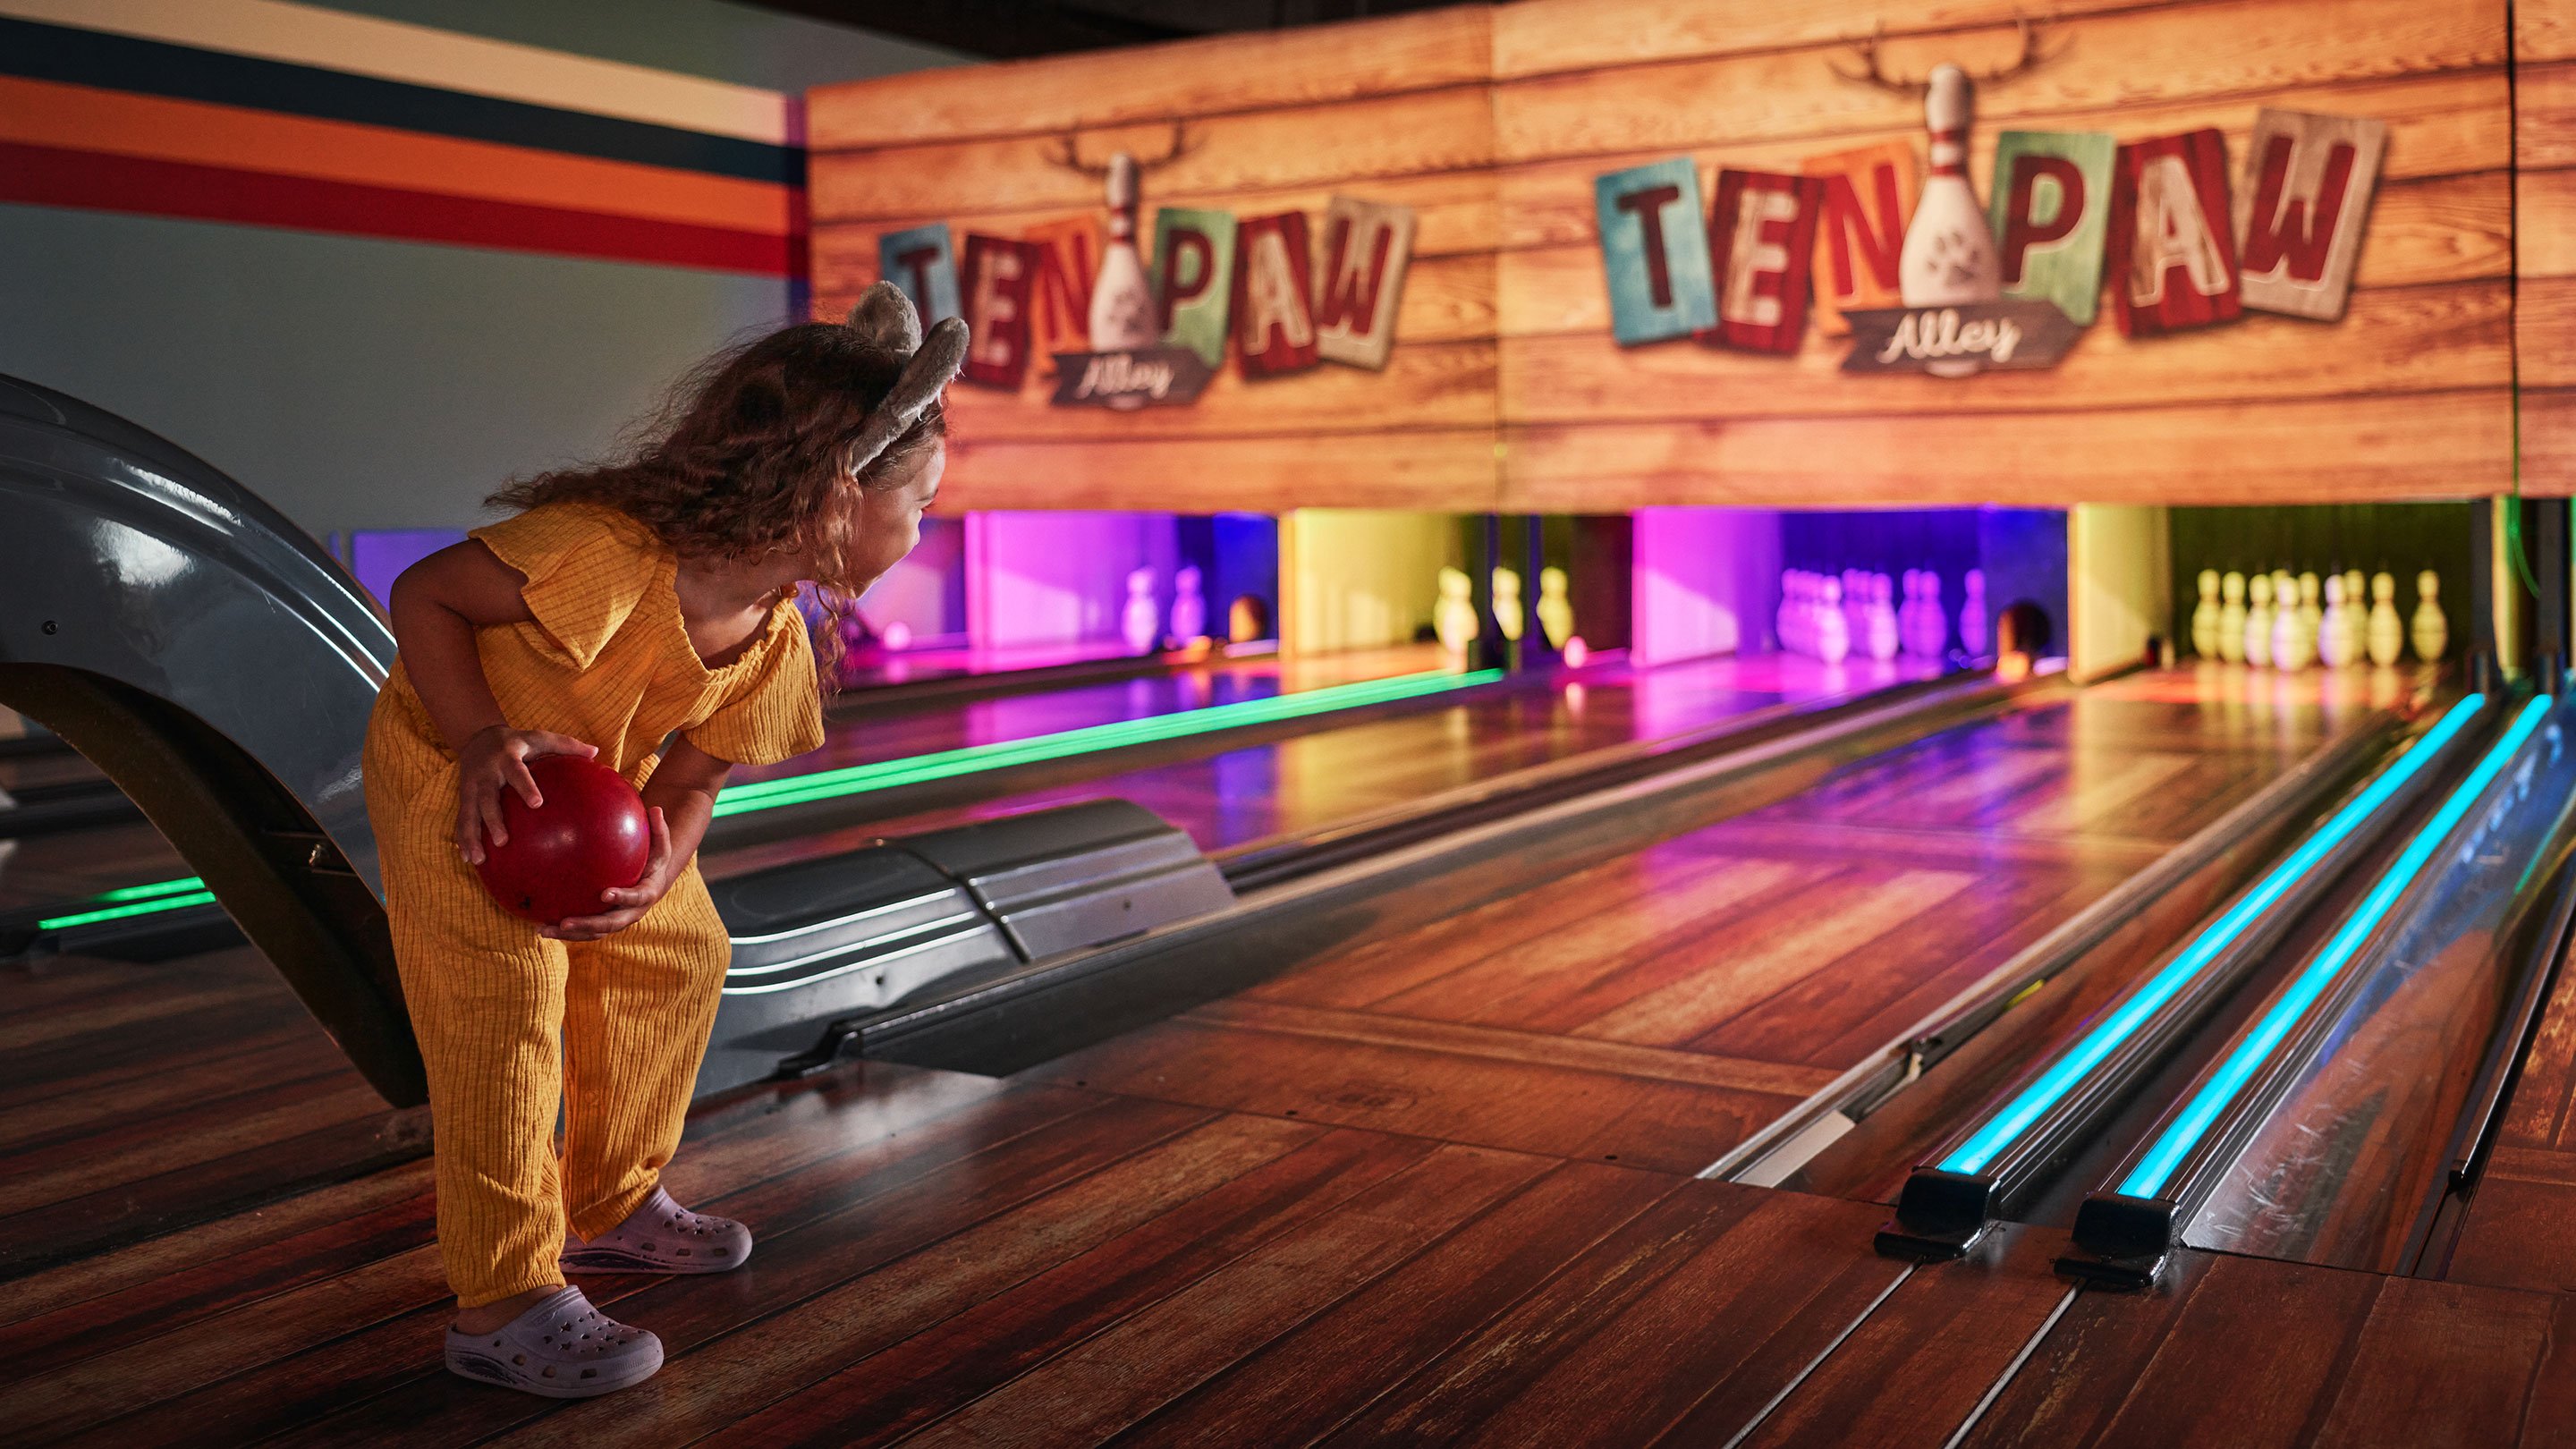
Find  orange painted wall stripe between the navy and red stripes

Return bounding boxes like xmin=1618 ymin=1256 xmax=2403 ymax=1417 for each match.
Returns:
xmin=0 ymin=75 xmax=801 ymax=234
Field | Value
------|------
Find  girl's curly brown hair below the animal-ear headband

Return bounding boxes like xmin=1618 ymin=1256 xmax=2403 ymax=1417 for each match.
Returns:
xmin=484 ymin=322 xmax=948 ymax=681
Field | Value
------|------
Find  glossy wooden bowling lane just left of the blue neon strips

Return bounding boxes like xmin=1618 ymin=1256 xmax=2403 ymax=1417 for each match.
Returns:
xmin=1033 ymin=670 xmax=2368 ymax=1171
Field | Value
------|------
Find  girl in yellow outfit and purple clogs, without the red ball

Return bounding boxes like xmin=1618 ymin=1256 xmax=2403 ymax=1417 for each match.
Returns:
xmin=366 ymin=284 xmax=966 ymax=1397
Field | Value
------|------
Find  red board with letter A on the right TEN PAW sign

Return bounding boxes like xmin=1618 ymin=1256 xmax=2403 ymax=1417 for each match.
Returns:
xmin=2107 ymin=129 xmax=2243 ymax=338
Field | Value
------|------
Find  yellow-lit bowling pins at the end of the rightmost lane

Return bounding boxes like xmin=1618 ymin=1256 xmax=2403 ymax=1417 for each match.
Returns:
xmin=2192 ymin=570 xmax=2450 ymax=670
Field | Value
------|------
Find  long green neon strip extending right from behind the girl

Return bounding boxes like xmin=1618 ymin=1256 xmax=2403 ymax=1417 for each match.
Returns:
xmin=716 ymin=670 xmax=1502 ymax=818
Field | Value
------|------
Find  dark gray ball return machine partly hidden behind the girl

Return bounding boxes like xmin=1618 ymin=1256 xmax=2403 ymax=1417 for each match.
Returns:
xmin=0 ymin=377 xmax=1234 ymax=1106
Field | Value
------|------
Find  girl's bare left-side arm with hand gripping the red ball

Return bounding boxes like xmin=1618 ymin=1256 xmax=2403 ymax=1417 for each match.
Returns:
xmin=389 ymin=538 xmax=595 ymax=864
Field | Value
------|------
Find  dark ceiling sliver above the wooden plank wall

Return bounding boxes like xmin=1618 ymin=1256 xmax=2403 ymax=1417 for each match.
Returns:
xmin=752 ymin=0 xmax=1458 ymax=59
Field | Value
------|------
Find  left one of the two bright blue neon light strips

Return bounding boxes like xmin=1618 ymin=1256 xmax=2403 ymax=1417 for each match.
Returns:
xmin=1940 ymin=693 xmax=2486 ymax=1174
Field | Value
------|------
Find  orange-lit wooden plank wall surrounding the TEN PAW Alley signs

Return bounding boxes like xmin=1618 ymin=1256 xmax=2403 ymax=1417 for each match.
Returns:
xmin=811 ymin=0 xmax=2524 ymax=511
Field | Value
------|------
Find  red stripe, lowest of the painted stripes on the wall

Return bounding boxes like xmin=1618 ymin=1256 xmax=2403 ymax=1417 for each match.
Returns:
xmin=0 ymin=142 xmax=804 ymax=275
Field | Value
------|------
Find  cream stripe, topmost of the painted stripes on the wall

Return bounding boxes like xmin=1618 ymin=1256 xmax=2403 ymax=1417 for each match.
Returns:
xmin=0 ymin=0 xmax=804 ymax=147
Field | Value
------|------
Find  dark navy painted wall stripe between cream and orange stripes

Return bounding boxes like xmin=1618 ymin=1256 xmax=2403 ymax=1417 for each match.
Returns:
xmin=0 ymin=16 xmax=804 ymax=186
